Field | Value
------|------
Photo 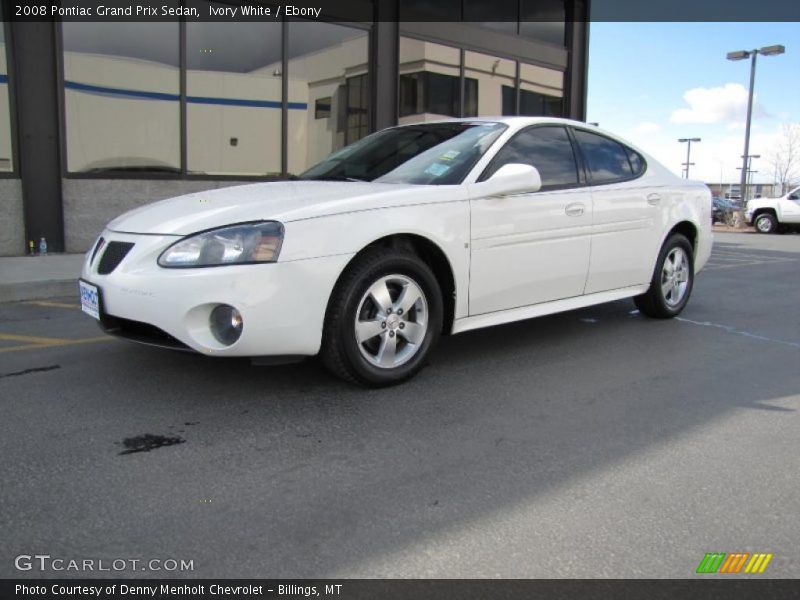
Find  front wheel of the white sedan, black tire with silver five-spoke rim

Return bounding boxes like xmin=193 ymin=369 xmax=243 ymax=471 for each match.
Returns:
xmin=320 ymin=248 xmax=444 ymax=387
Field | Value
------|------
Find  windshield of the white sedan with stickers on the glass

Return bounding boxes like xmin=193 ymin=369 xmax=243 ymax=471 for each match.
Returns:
xmin=298 ymin=121 xmax=506 ymax=185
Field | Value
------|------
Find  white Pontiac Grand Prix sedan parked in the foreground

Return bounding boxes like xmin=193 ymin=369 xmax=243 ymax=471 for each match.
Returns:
xmin=80 ymin=117 xmax=712 ymax=386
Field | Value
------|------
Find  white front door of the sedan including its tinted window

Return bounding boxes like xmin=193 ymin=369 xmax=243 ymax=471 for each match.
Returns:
xmin=469 ymin=125 xmax=592 ymax=315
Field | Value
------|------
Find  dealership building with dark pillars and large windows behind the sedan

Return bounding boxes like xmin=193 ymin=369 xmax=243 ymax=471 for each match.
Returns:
xmin=0 ymin=0 xmax=589 ymax=256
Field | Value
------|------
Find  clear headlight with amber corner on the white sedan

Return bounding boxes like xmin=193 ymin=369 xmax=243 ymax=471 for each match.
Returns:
xmin=158 ymin=221 xmax=283 ymax=268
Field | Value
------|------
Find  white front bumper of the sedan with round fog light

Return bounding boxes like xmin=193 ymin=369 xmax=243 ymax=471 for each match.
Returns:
xmin=82 ymin=231 xmax=352 ymax=356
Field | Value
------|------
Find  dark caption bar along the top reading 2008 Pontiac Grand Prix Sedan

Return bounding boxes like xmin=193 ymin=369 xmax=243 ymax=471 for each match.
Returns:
xmin=0 ymin=0 xmax=800 ymax=23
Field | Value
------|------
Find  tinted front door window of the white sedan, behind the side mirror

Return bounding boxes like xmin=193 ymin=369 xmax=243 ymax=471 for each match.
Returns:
xmin=481 ymin=126 xmax=578 ymax=189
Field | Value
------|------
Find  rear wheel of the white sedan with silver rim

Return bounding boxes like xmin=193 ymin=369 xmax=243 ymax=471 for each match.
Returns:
xmin=633 ymin=233 xmax=694 ymax=319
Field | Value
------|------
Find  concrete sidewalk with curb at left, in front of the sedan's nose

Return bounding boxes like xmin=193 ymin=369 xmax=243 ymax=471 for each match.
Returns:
xmin=0 ymin=254 xmax=84 ymax=302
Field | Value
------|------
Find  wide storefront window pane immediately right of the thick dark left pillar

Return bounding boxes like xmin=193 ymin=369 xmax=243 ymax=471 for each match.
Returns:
xmin=62 ymin=22 xmax=181 ymax=173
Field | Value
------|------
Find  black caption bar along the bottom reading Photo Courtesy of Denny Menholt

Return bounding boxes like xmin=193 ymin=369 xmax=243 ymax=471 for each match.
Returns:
xmin=0 ymin=575 xmax=800 ymax=600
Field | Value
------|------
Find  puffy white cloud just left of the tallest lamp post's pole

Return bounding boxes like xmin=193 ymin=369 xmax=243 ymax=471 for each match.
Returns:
xmin=670 ymin=83 xmax=764 ymax=124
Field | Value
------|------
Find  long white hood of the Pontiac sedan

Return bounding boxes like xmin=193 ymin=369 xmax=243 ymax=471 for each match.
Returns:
xmin=108 ymin=181 xmax=438 ymax=235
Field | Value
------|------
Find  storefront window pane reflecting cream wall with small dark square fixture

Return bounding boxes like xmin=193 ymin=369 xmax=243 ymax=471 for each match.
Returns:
xmin=186 ymin=16 xmax=283 ymax=175
